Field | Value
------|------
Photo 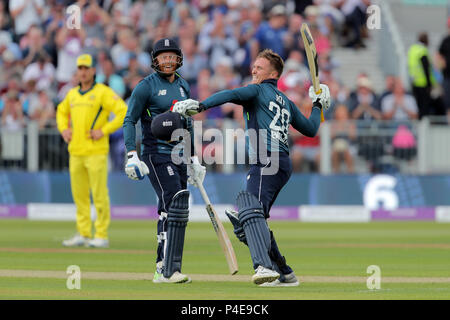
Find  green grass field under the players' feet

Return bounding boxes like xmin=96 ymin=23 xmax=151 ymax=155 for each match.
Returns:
xmin=0 ymin=219 xmax=450 ymax=300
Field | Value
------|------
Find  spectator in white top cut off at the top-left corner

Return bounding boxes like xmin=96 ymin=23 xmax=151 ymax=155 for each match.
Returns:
xmin=9 ymin=0 xmax=44 ymax=42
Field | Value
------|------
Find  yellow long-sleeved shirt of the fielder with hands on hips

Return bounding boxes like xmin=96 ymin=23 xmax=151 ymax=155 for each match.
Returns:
xmin=56 ymin=83 xmax=127 ymax=156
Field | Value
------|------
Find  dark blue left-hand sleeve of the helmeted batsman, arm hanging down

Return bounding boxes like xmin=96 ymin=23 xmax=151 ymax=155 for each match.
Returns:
xmin=123 ymin=80 xmax=150 ymax=152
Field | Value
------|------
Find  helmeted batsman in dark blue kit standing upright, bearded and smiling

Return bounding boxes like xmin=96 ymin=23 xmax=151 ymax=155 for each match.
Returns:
xmin=123 ymin=39 xmax=206 ymax=283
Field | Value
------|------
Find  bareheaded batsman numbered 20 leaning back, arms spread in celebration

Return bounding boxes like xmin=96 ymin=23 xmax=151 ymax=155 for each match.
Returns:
xmin=173 ymin=49 xmax=331 ymax=287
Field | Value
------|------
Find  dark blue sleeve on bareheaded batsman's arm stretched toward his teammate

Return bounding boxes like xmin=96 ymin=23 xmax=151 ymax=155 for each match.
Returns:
xmin=201 ymin=84 xmax=259 ymax=109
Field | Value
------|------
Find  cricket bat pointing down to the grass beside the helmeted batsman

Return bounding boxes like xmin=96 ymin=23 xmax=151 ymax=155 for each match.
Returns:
xmin=197 ymin=180 xmax=238 ymax=275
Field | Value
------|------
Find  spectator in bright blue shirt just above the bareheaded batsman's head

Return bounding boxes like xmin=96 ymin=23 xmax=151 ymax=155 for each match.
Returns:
xmin=251 ymin=4 xmax=288 ymax=61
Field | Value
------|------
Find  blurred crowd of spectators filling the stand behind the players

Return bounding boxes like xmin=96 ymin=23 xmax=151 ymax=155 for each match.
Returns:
xmin=0 ymin=0 xmax=448 ymax=172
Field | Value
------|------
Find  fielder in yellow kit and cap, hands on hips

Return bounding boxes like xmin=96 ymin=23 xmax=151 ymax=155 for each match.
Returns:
xmin=56 ymin=54 xmax=127 ymax=248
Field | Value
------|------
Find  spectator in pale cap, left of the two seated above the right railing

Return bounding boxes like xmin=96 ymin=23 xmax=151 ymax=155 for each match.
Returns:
xmin=347 ymin=75 xmax=382 ymax=120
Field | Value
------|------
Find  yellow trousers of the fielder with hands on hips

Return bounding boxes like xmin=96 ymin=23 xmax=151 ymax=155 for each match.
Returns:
xmin=69 ymin=155 xmax=111 ymax=239
